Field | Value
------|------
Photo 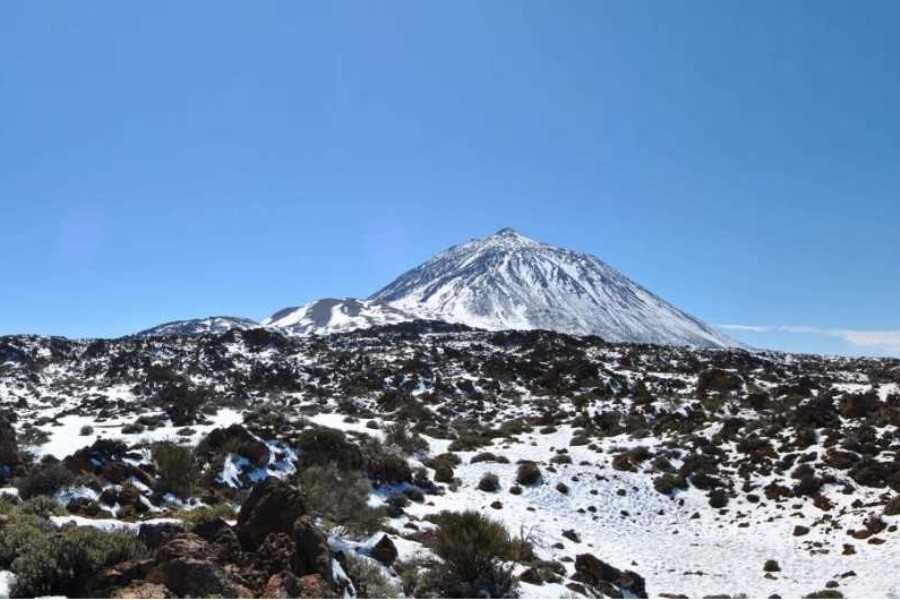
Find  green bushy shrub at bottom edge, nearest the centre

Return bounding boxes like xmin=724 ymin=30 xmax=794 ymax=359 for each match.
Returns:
xmin=434 ymin=511 xmax=518 ymax=598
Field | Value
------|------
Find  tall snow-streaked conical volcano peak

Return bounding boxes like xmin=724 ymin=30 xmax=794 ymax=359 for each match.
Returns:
xmin=369 ymin=228 xmax=737 ymax=347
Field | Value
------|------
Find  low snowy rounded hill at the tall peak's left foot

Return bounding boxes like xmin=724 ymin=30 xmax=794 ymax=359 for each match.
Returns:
xmin=262 ymin=298 xmax=416 ymax=335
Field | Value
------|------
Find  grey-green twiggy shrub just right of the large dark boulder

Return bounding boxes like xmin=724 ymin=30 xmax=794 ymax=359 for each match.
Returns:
xmin=299 ymin=463 xmax=384 ymax=534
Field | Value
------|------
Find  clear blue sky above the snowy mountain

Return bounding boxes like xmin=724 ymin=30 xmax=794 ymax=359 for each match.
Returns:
xmin=0 ymin=0 xmax=900 ymax=354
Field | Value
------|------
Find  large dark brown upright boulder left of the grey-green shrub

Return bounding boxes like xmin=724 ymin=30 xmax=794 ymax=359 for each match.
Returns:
xmin=237 ymin=477 xmax=306 ymax=550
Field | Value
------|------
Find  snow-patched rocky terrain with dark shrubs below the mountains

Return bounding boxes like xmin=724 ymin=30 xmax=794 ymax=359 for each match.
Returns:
xmin=0 ymin=321 xmax=900 ymax=598
